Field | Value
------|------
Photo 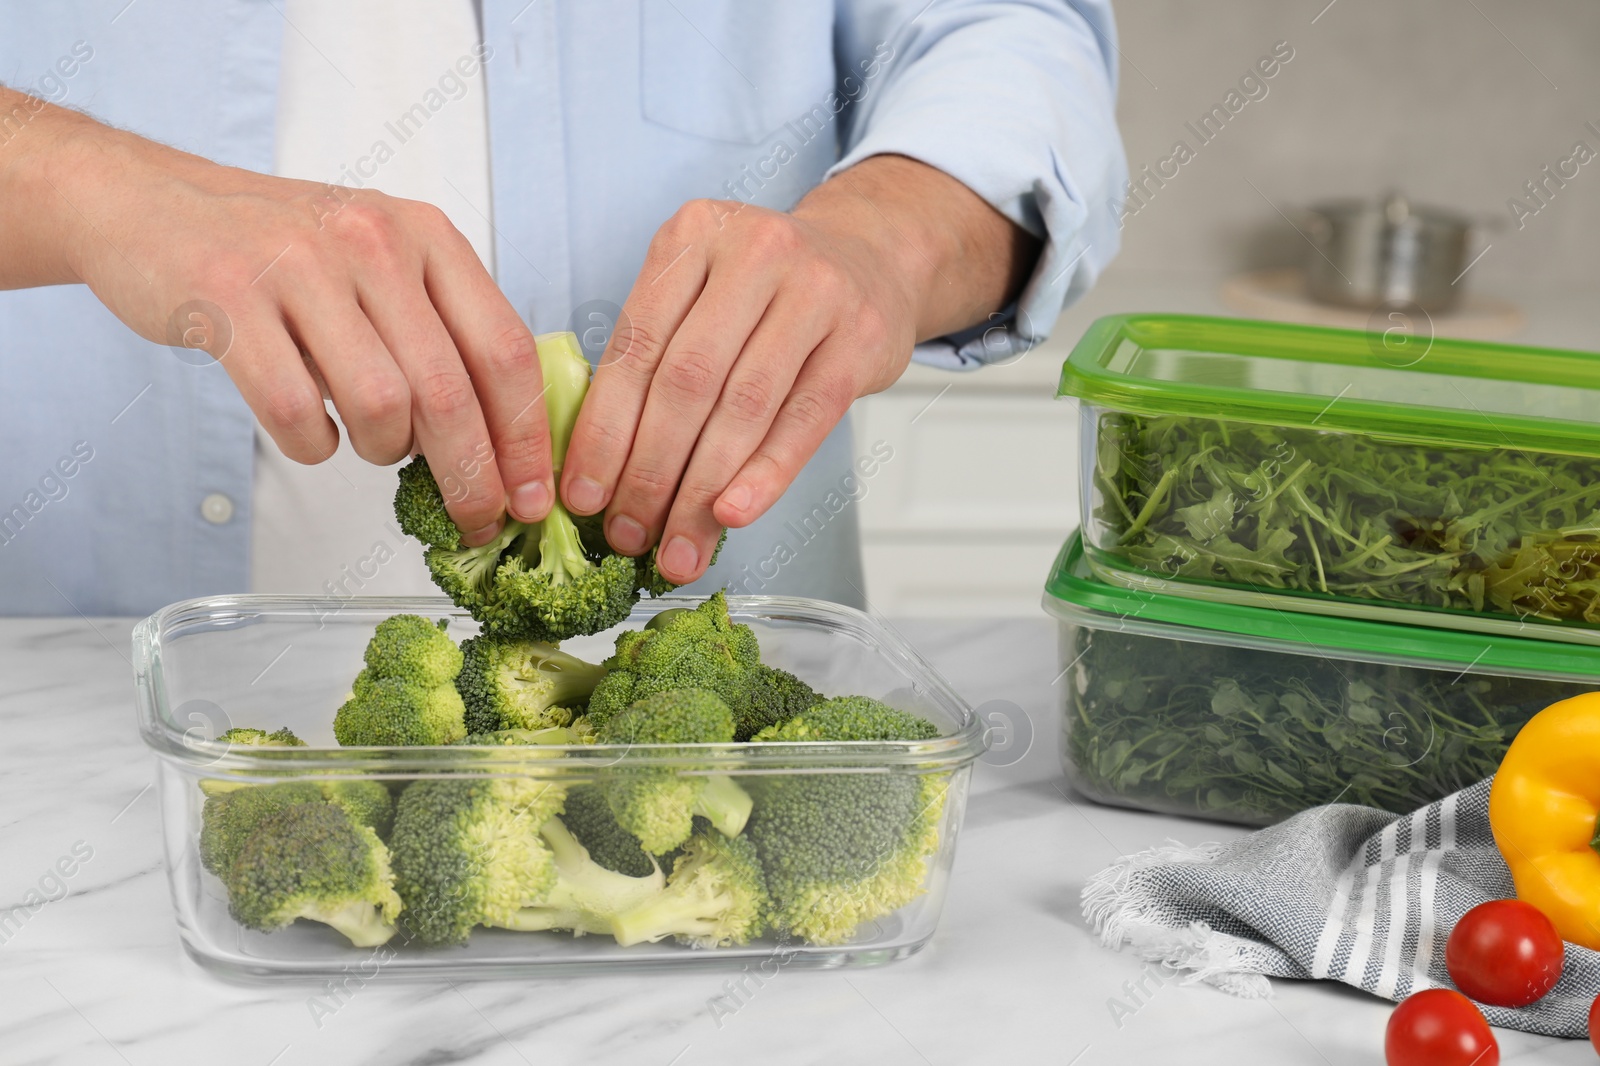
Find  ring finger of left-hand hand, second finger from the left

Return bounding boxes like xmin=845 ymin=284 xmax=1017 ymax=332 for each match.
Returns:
xmin=288 ymin=278 xmax=411 ymax=466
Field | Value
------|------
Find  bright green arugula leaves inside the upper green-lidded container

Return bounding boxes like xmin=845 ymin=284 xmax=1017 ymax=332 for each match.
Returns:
xmin=1091 ymin=413 xmax=1600 ymax=623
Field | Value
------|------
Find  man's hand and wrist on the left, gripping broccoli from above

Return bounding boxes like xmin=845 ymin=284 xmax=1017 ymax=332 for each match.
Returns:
xmin=0 ymin=90 xmax=554 ymax=544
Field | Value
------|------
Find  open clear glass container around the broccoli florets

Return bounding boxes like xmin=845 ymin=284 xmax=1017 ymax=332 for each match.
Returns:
xmin=133 ymin=595 xmax=982 ymax=978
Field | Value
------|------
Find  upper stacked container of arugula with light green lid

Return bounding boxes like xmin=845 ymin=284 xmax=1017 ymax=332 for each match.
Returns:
xmin=1061 ymin=307 xmax=1600 ymax=643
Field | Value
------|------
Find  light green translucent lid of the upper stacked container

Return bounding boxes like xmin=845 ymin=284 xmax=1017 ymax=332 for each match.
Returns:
xmin=1059 ymin=314 xmax=1600 ymax=456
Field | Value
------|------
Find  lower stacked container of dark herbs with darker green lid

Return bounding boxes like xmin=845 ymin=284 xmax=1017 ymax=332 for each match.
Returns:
xmin=1045 ymin=535 xmax=1600 ymax=824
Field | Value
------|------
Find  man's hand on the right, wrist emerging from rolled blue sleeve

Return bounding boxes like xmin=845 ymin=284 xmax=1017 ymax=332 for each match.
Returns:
xmin=562 ymin=155 xmax=1038 ymax=584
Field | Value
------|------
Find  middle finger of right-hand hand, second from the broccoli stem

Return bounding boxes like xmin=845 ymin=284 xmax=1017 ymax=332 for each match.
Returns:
xmin=606 ymin=256 xmax=782 ymax=555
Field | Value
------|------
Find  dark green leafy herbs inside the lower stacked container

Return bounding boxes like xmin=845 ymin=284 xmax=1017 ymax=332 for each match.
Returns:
xmin=1062 ymin=626 xmax=1587 ymax=824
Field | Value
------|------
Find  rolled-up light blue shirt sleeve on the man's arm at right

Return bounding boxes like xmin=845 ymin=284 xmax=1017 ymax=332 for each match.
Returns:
xmin=829 ymin=0 xmax=1128 ymax=370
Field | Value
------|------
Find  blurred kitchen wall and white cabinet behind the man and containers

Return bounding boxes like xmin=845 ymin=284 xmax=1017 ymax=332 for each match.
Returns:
xmin=854 ymin=0 xmax=1600 ymax=616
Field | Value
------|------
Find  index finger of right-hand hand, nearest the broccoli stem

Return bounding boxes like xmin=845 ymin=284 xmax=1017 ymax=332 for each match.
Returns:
xmin=562 ymin=211 xmax=709 ymax=514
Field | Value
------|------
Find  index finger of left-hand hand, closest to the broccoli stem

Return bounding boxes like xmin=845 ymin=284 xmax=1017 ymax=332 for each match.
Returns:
xmin=424 ymin=222 xmax=555 ymax=522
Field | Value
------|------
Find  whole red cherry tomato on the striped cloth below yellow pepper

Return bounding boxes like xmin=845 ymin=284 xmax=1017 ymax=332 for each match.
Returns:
xmin=1445 ymin=900 xmax=1562 ymax=1007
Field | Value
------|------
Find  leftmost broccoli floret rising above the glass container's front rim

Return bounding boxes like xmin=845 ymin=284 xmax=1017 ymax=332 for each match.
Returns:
xmin=333 ymin=615 xmax=467 ymax=747
